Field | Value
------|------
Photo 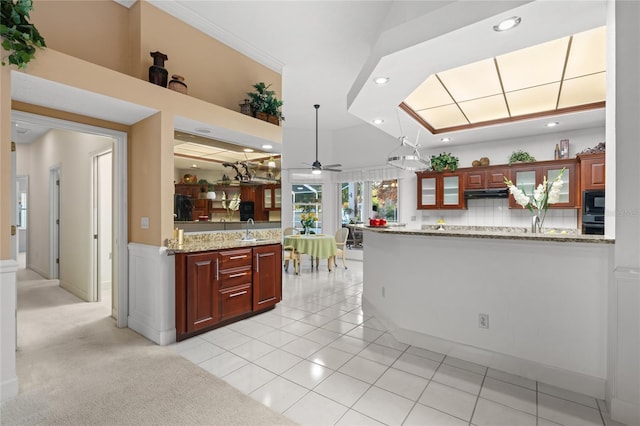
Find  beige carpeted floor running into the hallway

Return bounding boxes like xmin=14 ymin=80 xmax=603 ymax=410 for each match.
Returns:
xmin=0 ymin=270 xmax=293 ymax=425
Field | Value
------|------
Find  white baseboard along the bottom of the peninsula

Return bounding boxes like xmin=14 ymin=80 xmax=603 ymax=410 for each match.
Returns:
xmin=362 ymin=297 xmax=606 ymax=399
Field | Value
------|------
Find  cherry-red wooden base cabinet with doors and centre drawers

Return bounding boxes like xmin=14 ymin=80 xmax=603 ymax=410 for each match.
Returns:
xmin=175 ymin=244 xmax=282 ymax=341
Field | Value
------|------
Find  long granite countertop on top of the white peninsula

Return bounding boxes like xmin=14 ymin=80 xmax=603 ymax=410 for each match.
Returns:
xmin=355 ymin=224 xmax=615 ymax=244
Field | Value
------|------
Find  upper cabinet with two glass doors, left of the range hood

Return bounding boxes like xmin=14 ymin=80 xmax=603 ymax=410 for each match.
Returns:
xmin=416 ymin=172 xmax=465 ymax=210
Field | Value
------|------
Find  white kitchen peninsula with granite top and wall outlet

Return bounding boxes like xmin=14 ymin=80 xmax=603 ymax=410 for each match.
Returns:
xmin=362 ymin=226 xmax=614 ymax=398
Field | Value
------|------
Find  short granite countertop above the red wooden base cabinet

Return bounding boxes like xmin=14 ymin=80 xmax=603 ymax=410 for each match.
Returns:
xmin=167 ymin=228 xmax=282 ymax=254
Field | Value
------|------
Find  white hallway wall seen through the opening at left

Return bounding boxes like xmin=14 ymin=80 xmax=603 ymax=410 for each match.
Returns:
xmin=19 ymin=130 xmax=113 ymax=300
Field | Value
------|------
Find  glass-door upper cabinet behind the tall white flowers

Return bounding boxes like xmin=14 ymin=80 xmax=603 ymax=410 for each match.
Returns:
xmin=509 ymin=159 xmax=580 ymax=209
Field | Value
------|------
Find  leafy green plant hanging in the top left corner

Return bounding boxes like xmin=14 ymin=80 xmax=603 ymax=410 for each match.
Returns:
xmin=0 ymin=0 xmax=47 ymax=69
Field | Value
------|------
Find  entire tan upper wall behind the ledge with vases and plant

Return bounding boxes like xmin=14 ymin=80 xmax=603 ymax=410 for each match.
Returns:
xmin=31 ymin=0 xmax=282 ymax=111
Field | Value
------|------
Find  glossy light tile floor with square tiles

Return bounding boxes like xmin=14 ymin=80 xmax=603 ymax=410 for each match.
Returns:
xmin=172 ymin=260 xmax=618 ymax=426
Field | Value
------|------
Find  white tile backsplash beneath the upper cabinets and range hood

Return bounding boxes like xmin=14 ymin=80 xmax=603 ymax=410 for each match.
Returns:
xmin=418 ymin=198 xmax=578 ymax=229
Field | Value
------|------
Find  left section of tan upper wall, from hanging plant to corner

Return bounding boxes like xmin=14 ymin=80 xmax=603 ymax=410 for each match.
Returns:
xmin=31 ymin=0 xmax=129 ymax=73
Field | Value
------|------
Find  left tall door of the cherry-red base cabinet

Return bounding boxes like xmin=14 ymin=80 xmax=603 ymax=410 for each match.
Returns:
xmin=187 ymin=253 xmax=219 ymax=333
